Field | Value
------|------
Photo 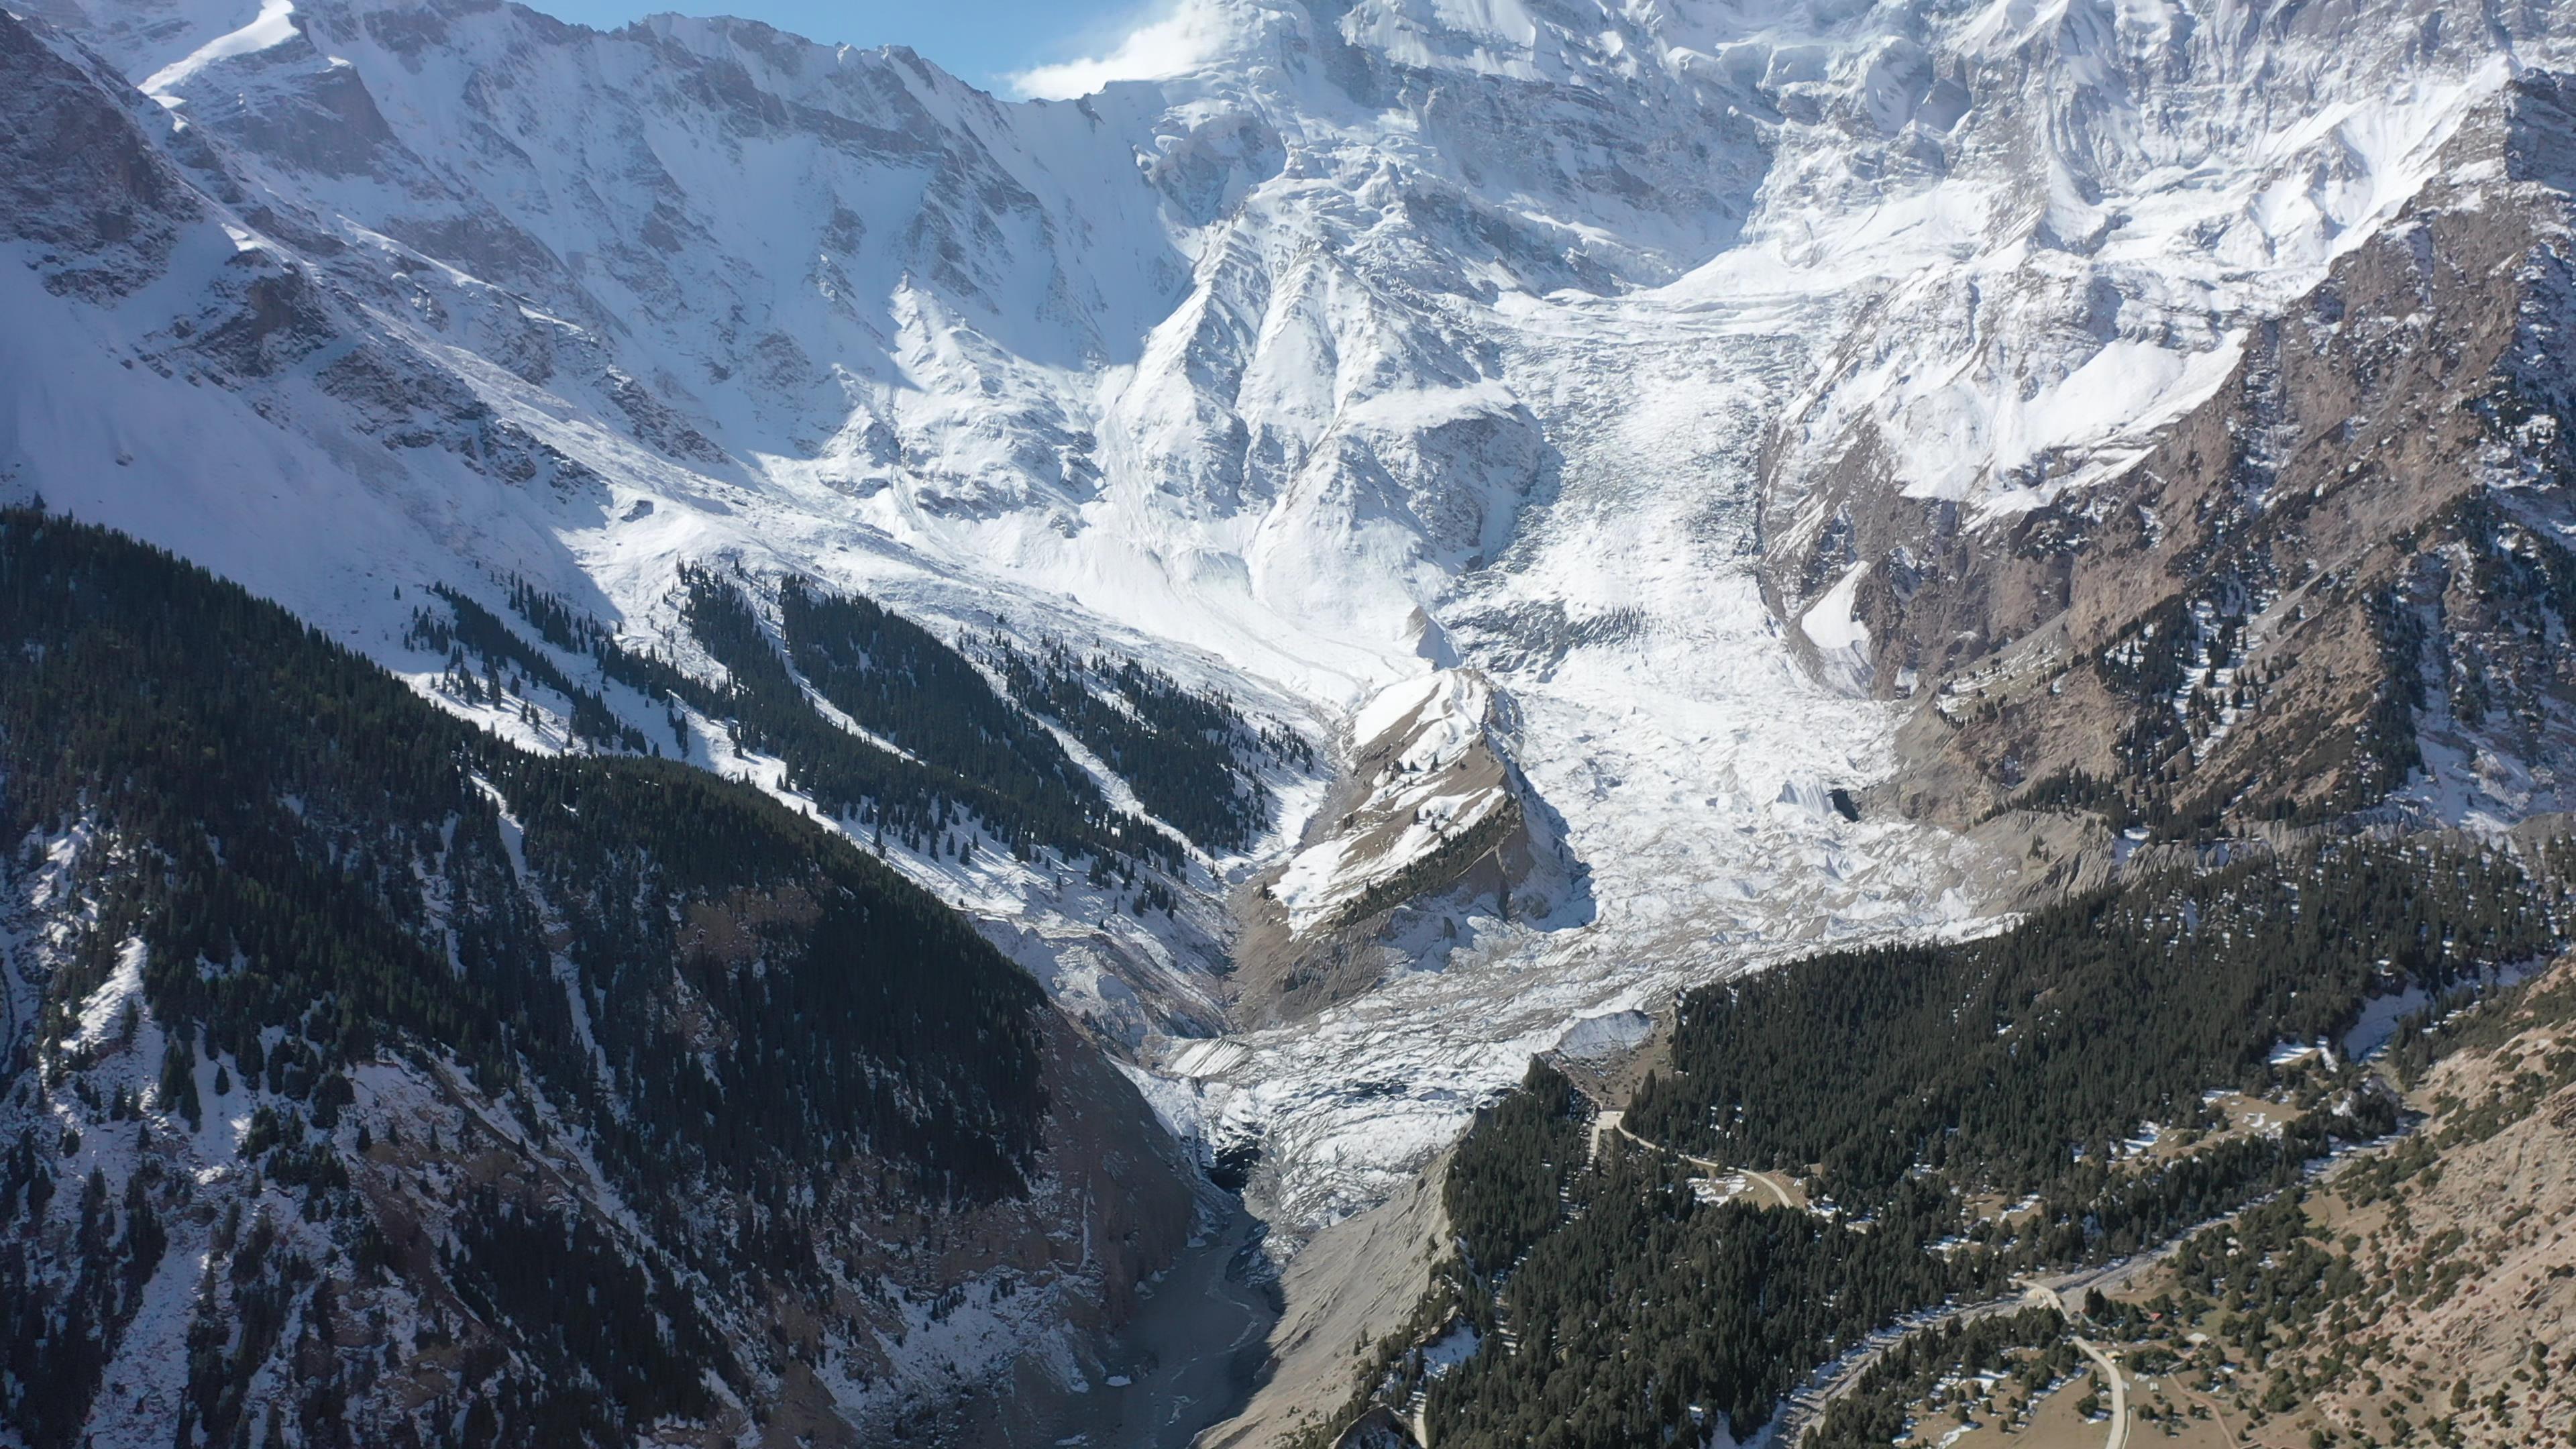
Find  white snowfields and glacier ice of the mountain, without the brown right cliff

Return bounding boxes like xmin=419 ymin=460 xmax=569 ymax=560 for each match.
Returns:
xmin=0 ymin=0 xmax=2568 ymax=1227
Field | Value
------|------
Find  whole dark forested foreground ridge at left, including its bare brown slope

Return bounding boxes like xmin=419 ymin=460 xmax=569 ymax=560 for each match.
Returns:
xmin=0 ymin=511 xmax=1211 ymax=1446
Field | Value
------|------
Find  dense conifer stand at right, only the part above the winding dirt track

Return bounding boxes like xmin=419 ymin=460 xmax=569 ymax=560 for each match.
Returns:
xmin=1628 ymin=841 xmax=2563 ymax=1201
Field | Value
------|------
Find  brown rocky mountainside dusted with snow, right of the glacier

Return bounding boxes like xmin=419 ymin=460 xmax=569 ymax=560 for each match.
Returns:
xmin=1778 ymin=74 xmax=2571 ymax=835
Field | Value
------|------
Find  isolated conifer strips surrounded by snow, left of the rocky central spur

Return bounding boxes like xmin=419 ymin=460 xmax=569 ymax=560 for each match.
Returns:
xmin=407 ymin=568 xmax=1313 ymax=876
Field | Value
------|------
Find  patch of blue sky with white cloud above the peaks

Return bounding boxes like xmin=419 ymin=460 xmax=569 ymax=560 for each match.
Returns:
xmin=525 ymin=0 xmax=1169 ymax=95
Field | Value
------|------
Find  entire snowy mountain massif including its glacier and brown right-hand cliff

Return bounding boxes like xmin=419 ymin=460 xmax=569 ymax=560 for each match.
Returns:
xmin=0 ymin=0 xmax=2576 ymax=1361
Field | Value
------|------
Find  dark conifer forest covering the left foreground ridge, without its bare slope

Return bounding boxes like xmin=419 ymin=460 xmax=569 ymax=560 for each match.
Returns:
xmin=0 ymin=511 xmax=1108 ymax=1449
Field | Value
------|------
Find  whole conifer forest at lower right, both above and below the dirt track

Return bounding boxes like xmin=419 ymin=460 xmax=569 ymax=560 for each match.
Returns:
xmin=1344 ymin=841 xmax=2568 ymax=1449
